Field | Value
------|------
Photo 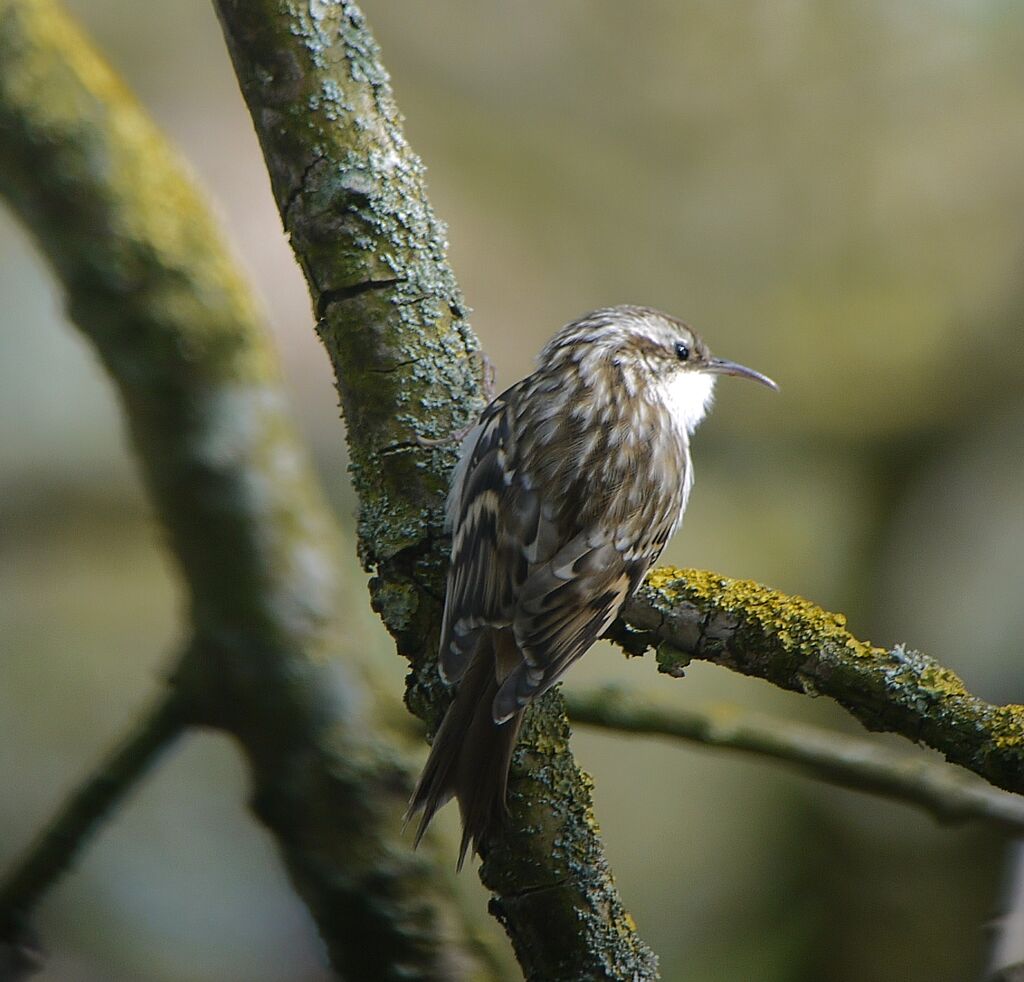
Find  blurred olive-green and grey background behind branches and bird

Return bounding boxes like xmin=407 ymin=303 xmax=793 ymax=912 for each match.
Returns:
xmin=0 ymin=0 xmax=1024 ymax=982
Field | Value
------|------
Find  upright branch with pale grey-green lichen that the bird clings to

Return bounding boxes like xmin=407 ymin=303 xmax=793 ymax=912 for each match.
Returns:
xmin=216 ymin=0 xmax=655 ymax=982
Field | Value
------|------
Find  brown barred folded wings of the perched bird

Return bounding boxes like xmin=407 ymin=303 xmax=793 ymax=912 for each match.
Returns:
xmin=440 ymin=380 xmax=663 ymax=723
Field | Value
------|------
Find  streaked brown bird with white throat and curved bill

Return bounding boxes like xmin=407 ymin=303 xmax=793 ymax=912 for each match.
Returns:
xmin=407 ymin=305 xmax=778 ymax=869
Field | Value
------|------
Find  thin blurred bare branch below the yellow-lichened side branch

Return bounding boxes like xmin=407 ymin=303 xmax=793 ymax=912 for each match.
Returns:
xmin=565 ymin=688 xmax=1024 ymax=836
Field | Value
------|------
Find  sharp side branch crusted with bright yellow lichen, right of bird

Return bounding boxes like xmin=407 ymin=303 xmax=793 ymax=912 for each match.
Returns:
xmin=613 ymin=567 xmax=1024 ymax=794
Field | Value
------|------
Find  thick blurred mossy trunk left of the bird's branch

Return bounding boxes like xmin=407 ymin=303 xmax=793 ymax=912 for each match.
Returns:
xmin=0 ymin=0 xmax=491 ymax=979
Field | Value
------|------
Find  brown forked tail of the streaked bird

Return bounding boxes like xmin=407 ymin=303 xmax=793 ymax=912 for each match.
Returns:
xmin=408 ymin=631 xmax=522 ymax=869
